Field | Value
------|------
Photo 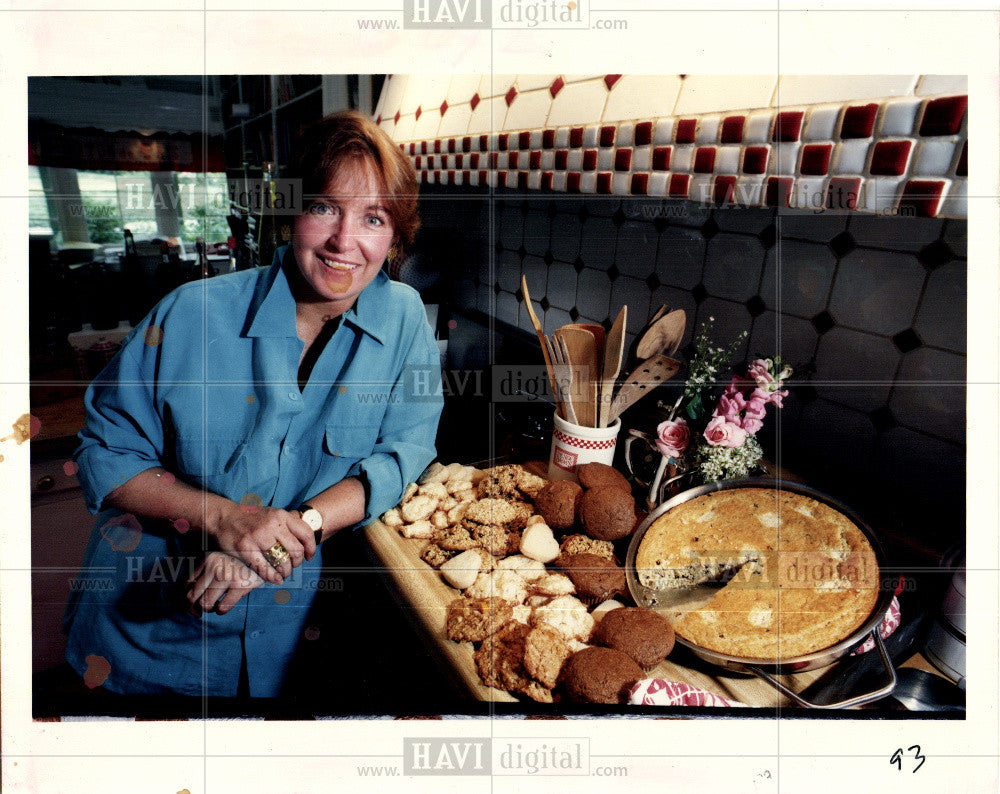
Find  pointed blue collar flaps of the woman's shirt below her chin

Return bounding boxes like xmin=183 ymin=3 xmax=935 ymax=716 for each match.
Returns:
xmin=245 ymin=245 xmax=391 ymax=344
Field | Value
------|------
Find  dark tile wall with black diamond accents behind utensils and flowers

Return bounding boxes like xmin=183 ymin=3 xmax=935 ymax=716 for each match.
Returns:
xmin=433 ymin=186 xmax=968 ymax=544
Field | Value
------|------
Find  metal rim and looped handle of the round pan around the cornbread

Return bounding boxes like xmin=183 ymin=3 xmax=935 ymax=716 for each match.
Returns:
xmin=625 ymin=477 xmax=896 ymax=708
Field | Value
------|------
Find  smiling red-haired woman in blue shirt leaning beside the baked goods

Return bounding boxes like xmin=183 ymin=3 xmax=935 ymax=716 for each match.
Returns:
xmin=65 ymin=112 xmax=442 ymax=697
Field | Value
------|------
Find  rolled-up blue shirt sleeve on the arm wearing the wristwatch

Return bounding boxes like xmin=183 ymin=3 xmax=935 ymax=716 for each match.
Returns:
xmin=348 ymin=307 xmax=444 ymax=524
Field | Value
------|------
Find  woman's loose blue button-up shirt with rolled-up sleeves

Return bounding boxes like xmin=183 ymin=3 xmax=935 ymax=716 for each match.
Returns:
xmin=66 ymin=248 xmax=442 ymax=696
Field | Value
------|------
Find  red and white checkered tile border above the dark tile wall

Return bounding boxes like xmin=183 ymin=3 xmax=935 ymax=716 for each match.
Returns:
xmin=376 ymin=75 xmax=968 ymax=218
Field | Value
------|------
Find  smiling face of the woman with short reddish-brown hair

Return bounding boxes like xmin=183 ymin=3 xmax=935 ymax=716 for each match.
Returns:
xmin=292 ymin=157 xmax=396 ymax=314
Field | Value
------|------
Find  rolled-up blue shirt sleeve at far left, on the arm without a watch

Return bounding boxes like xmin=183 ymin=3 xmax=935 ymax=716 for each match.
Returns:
xmin=75 ymin=330 xmax=164 ymax=514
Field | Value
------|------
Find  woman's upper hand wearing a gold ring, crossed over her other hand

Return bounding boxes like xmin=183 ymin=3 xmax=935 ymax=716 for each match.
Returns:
xmin=207 ymin=501 xmax=316 ymax=584
